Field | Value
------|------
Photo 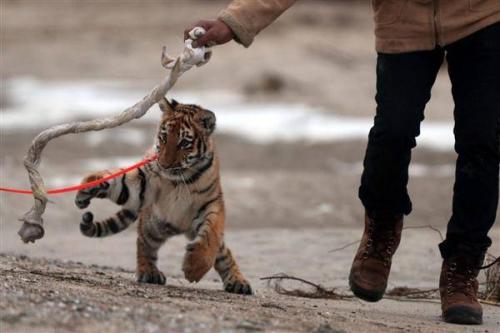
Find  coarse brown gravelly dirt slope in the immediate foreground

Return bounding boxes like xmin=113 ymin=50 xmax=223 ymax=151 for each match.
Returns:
xmin=0 ymin=250 xmax=500 ymax=333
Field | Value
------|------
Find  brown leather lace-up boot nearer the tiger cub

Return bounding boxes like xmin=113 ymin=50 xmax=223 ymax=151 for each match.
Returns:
xmin=349 ymin=214 xmax=403 ymax=302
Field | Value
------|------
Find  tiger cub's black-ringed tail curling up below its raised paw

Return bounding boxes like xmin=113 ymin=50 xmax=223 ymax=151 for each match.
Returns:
xmin=80 ymin=209 xmax=137 ymax=237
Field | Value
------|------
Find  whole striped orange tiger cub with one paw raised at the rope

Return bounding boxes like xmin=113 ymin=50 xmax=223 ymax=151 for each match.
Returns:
xmin=75 ymin=98 xmax=252 ymax=294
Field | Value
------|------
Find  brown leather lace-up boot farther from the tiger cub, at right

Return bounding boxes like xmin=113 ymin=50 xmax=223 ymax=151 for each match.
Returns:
xmin=439 ymin=255 xmax=483 ymax=325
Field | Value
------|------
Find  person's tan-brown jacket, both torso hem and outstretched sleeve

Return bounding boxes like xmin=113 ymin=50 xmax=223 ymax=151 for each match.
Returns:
xmin=219 ymin=0 xmax=500 ymax=53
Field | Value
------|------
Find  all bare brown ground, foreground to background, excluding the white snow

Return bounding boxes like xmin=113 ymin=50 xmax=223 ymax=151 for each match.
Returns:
xmin=0 ymin=0 xmax=500 ymax=333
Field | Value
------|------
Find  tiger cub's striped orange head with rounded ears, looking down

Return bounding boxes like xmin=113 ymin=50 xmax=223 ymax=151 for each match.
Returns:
xmin=156 ymin=98 xmax=215 ymax=178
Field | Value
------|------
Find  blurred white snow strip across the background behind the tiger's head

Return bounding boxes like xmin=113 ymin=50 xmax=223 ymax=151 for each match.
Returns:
xmin=0 ymin=78 xmax=454 ymax=150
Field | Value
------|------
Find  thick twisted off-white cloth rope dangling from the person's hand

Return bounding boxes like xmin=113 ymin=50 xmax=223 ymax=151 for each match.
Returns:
xmin=18 ymin=27 xmax=211 ymax=243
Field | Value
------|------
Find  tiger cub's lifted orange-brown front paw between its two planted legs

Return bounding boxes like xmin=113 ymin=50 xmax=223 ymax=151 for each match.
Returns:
xmin=182 ymin=241 xmax=215 ymax=282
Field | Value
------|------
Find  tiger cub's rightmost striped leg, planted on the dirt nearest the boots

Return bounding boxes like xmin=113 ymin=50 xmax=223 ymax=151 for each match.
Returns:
xmin=214 ymin=243 xmax=253 ymax=295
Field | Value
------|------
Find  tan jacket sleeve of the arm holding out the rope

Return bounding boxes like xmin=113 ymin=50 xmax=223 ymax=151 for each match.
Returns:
xmin=218 ymin=0 xmax=296 ymax=47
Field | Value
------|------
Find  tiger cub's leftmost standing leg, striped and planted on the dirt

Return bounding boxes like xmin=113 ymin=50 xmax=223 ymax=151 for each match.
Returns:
xmin=137 ymin=213 xmax=170 ymax=284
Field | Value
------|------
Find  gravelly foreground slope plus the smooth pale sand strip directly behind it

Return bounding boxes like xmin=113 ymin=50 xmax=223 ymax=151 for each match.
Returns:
xmin=0 ymin=229 xmax=500 ymax=333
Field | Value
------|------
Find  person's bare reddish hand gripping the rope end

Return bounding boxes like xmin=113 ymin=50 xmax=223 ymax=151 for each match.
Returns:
xmin=184 ymin=20 xmax=234 ymax=47
